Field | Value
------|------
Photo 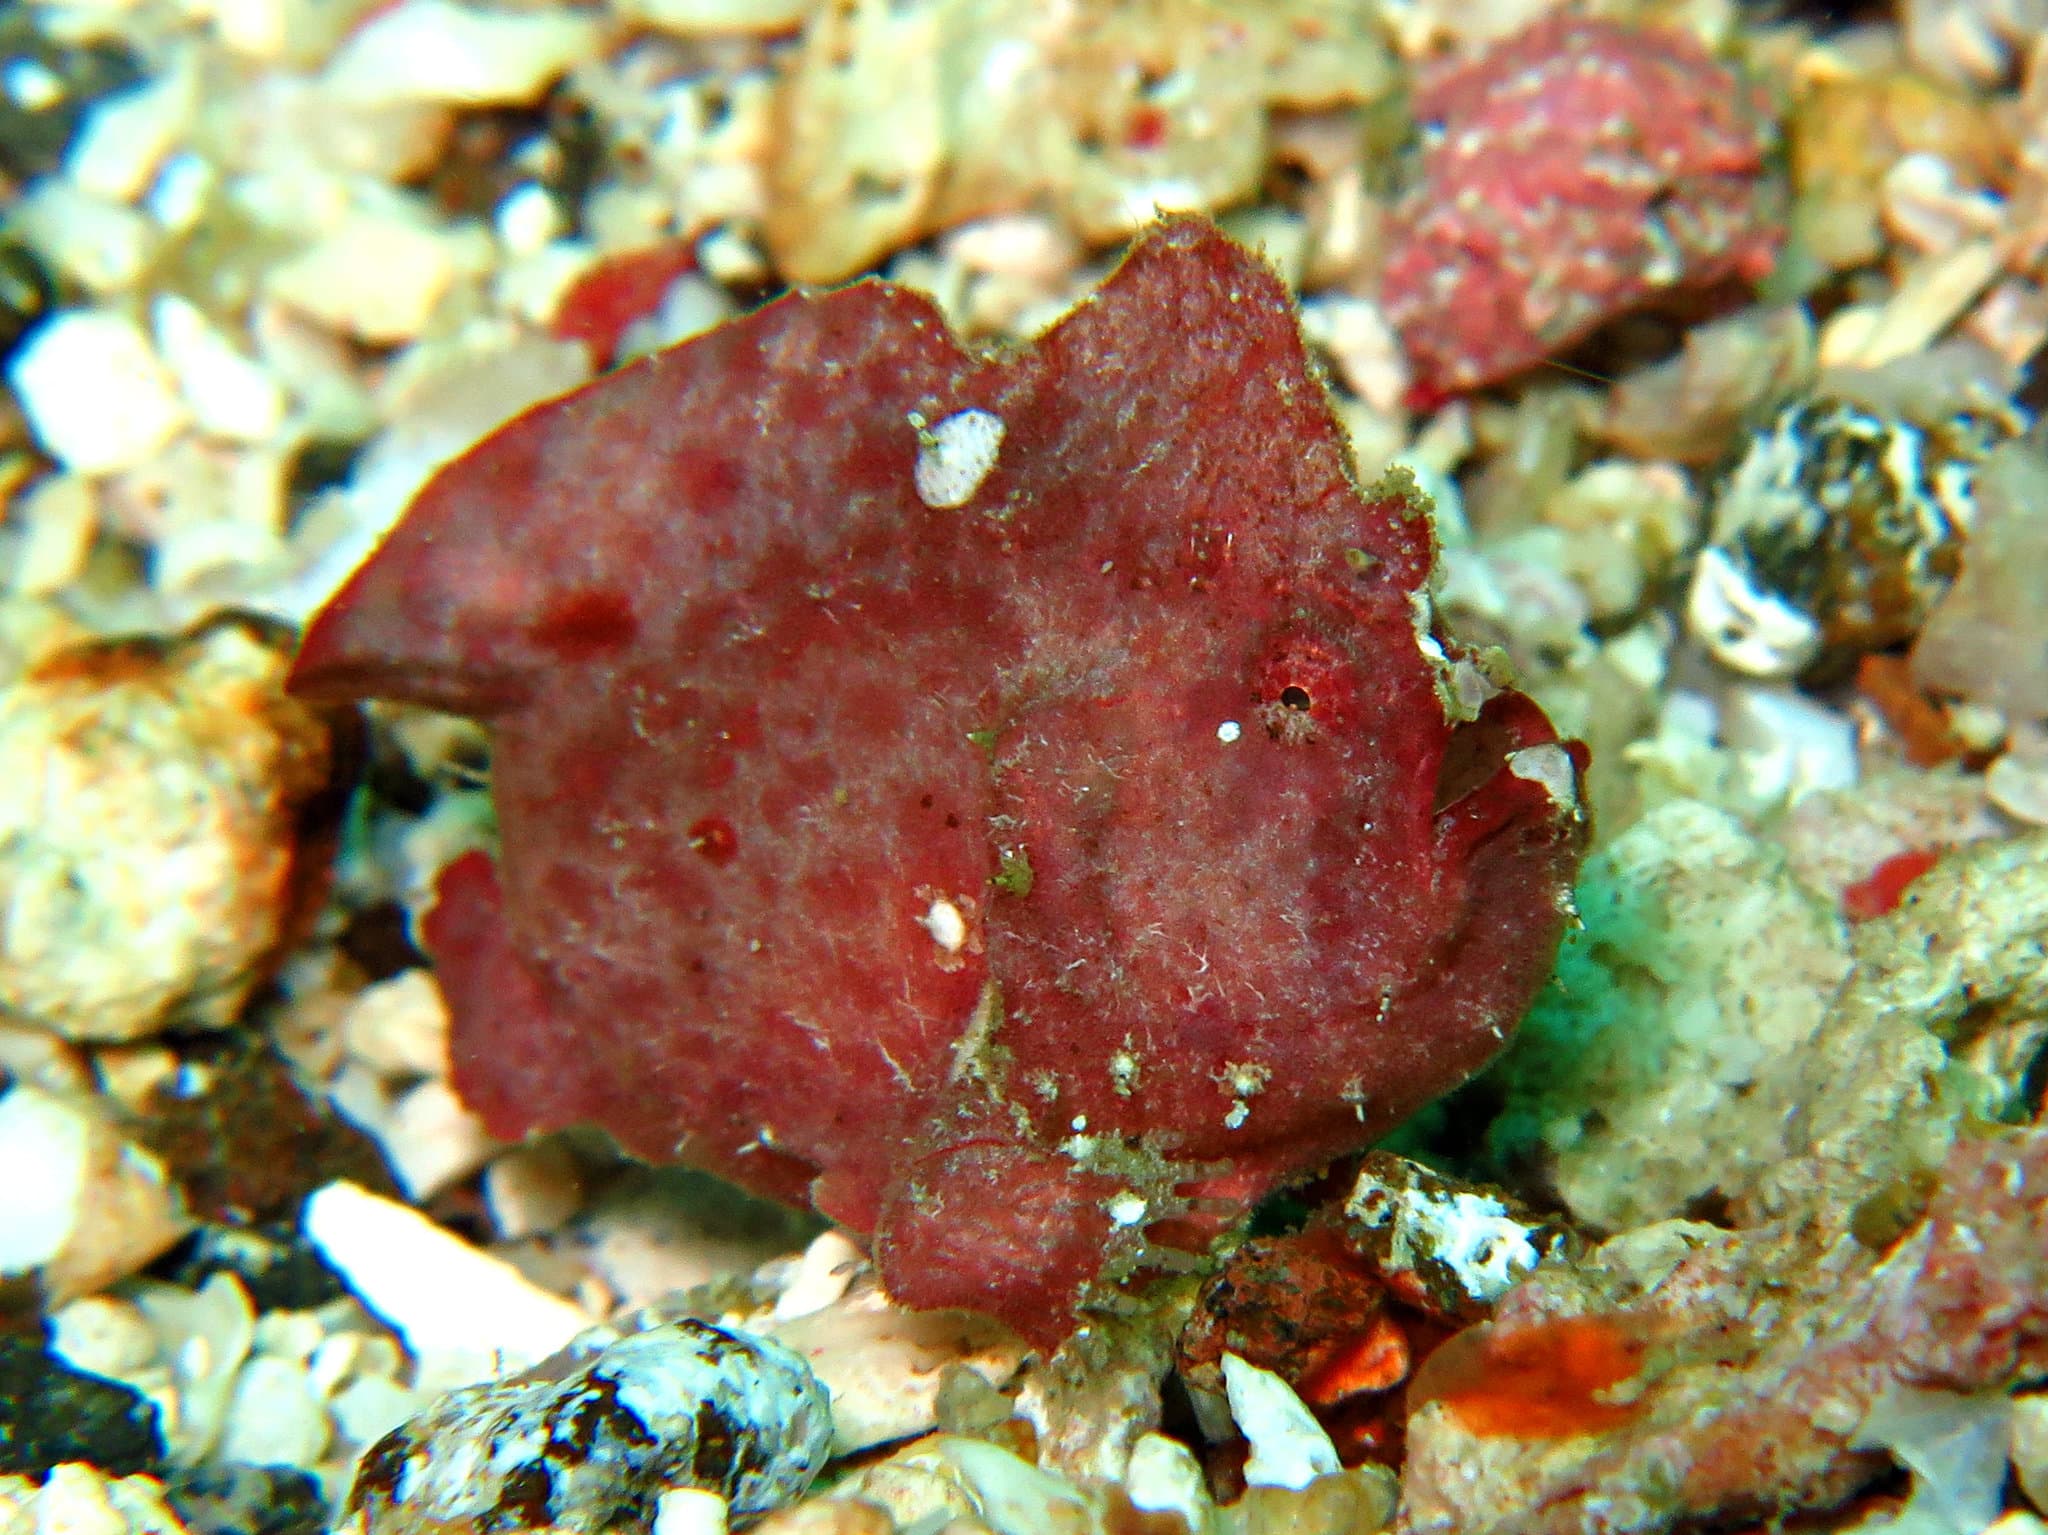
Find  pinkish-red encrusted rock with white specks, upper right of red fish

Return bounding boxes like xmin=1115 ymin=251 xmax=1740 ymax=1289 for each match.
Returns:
xmin=1380 ymin=14 xmax=1782 ymax=399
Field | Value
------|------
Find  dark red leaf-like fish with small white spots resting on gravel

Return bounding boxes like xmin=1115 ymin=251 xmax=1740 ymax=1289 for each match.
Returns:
xmin=295 ymin=221 xmax=1585 ymax=1341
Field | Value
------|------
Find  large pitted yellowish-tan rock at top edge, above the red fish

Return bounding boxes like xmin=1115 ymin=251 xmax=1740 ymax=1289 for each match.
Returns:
xmin=764 ymin=0 xmax=1393 ymax=282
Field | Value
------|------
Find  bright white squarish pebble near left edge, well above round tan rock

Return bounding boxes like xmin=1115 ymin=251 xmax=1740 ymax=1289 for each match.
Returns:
xmin=8 ymin=309 xmax=184 ymax=475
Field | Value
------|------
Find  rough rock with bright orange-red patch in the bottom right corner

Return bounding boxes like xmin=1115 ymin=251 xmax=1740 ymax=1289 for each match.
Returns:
xmin=1401 ymin=1128 xmax=2048 ymax=1535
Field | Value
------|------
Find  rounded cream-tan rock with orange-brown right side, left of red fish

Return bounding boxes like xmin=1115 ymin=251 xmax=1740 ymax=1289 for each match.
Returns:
xmin=0 ymin=620 xmax=330 ymax=1040
